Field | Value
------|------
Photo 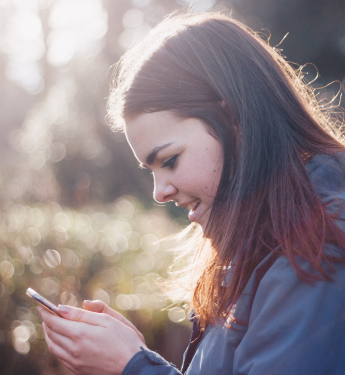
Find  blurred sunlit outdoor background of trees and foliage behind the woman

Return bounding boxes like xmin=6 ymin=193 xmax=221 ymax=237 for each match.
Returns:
xmin=0 ymin=0 xmax=345 ymax=375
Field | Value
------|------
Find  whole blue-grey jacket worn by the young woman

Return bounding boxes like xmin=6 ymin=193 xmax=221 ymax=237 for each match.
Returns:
xmin=122 ymin=153 xmax=345 ymax=375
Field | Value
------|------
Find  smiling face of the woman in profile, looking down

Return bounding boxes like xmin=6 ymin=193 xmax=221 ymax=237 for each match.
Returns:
xmin=126 ymin=111 xmax=223 ymax=230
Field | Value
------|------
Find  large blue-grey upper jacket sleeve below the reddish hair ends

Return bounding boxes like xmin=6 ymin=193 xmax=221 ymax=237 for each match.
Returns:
xmin=233 ymin=250 xmax=345 ymax=375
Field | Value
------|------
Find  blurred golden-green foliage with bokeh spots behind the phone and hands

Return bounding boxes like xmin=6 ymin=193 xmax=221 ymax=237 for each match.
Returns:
xmin=0 ymin=196 xmax=185 ymax=362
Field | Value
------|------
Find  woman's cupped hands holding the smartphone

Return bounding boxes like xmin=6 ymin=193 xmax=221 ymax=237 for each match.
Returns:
xmin=38 ymin=305 xmax=144 ymax=375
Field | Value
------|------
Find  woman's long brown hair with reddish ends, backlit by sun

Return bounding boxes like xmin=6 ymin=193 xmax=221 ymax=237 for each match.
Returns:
xmin=108 ymin=13 xmax=345 ymax=327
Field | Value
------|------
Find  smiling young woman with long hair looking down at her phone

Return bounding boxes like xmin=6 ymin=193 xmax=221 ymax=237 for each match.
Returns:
xmin=40 ymin=13 xmax=345 ymax=375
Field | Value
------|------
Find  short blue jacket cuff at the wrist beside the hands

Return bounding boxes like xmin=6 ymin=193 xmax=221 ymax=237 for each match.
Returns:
xmin=122 ymin=347 xmax=181 ymax=375
